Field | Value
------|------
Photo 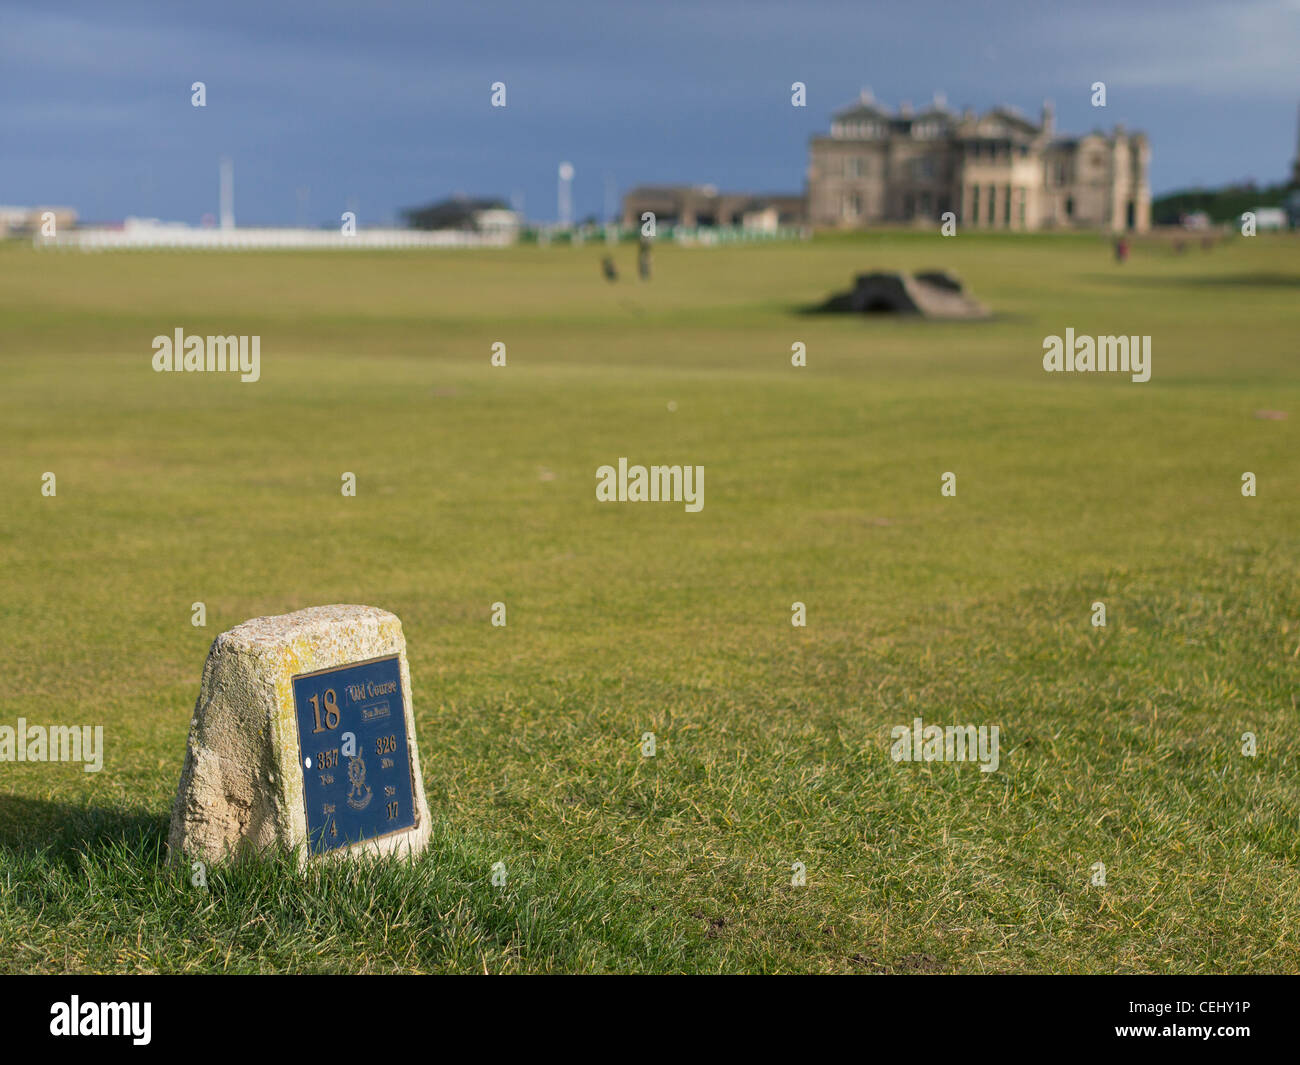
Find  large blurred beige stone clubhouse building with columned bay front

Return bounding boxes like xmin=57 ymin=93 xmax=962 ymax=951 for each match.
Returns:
xmin=807 ymin=92 xmax=1151 ymax=233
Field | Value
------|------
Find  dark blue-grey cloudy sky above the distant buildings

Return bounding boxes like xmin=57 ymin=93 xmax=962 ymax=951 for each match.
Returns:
xmin=0 ymin=0 xmax=1300 ymax=225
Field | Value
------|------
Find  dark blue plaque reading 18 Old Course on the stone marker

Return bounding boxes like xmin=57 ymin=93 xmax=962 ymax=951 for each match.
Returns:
xmin=293 ymin=654 xmax=416 ymax=854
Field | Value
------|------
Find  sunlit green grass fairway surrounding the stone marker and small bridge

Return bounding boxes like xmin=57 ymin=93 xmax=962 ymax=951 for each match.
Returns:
xmin=0 ymin=234 xmax=1300 ymax=973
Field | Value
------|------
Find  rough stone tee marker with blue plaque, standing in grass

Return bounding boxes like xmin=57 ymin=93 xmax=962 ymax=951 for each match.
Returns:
xmin=168 ymin=606 xmax=429 ymax=862
